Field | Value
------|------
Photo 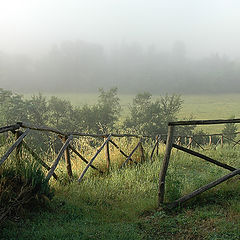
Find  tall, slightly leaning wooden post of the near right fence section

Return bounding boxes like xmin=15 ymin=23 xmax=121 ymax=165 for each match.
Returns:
xmin=158 ymin=126 xmax=174 ymax=207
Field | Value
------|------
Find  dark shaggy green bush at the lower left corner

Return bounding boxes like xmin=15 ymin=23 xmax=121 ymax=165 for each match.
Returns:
xmin=0 ymin=160 xmax=53 ymax=223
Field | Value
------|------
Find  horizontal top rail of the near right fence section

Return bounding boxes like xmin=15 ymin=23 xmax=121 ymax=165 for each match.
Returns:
xmin=168 ymin=118 xmax=240 ymax=126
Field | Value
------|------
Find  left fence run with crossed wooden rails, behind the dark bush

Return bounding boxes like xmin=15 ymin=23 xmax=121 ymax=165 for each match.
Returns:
xmin=0 ymin=122 xmax=146 ymax=182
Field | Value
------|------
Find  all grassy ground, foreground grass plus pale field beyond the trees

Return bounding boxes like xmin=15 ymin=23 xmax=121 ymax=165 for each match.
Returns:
xmin=0 ymin=91 xmax=237 ymax=240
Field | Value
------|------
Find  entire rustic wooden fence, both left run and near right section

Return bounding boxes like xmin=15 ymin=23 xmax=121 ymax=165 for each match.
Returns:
xmin=0 ymin=119 xmax=240 ymax=207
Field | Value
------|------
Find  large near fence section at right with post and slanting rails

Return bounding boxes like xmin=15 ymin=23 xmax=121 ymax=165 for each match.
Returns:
xmin=158 ymin=119 xmax=240 ymax=207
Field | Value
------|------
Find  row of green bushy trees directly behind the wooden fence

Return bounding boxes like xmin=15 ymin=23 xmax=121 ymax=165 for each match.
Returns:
xmin=0 ymin=88 xmax=238 ymax=150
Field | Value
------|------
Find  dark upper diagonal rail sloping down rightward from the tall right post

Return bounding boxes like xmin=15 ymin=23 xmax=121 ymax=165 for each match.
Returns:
xmin=172 ymin=144 xmax=236 ymax=171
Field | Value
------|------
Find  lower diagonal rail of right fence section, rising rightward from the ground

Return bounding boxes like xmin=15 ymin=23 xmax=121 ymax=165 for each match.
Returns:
xmin=170 ymin=169 xmax=240 ymax=207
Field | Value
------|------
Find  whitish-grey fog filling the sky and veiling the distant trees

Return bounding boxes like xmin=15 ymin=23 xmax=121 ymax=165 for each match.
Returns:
xmin=0 ymin=0 xmax=240 ymax=93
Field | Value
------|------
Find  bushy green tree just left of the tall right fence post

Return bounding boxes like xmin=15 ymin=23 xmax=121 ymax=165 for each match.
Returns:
xmin=124 ymin=92 xmax=182 ymax=136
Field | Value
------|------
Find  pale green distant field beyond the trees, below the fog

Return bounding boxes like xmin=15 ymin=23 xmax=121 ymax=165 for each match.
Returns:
xmin=25 ymin=93 xmax=240 ymax=133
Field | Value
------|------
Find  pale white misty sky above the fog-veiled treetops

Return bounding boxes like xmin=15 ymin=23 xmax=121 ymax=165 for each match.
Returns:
xmin=0 ymin=0 xmax=240 ymax=59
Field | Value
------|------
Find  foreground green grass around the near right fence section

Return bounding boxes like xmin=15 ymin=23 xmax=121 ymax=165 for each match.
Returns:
xmin=0 ymin=140 xmax=240 ymax=240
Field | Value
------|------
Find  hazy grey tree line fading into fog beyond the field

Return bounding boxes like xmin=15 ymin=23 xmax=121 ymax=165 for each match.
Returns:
xmin=0 ymin=41 xmax=240 ymax=94
